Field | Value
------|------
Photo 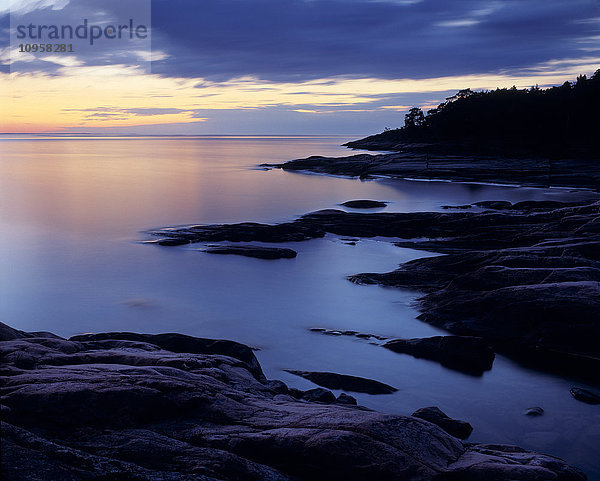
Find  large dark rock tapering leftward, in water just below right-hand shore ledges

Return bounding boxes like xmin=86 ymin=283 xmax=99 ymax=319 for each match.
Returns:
xmin=383 ymin=336 xmax=495 ymax=375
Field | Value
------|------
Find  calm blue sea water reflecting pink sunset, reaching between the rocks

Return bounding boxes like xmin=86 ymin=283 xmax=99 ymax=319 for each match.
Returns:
xmin=0 ymin=135 xmax=600 ymax=479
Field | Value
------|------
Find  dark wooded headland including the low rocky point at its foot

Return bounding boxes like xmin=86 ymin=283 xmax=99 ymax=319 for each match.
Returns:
xmin=267 ymin=70 xmax=600 ymax=189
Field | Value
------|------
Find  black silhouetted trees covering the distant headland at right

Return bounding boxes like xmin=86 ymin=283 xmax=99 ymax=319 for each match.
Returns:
xmin=352 ymin=69 xmax=600 ymax=159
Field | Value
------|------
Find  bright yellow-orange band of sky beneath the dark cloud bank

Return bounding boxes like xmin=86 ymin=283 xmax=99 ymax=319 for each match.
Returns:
xmin=0 ymin=57 xmax=600 ymax=133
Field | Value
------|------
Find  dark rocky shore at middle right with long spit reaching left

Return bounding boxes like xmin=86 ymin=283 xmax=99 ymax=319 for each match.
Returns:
xmin=152 ymin=201 xmax=600 ymax=377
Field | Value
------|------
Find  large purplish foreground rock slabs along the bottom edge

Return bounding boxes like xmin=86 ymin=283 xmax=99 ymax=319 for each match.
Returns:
xmin=0 ymin=324 xmax=586 ymax=481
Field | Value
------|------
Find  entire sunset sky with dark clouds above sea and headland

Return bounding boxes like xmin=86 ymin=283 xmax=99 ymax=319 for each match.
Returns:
xmin=0 ymin=0 xmax=600 ymax=135
